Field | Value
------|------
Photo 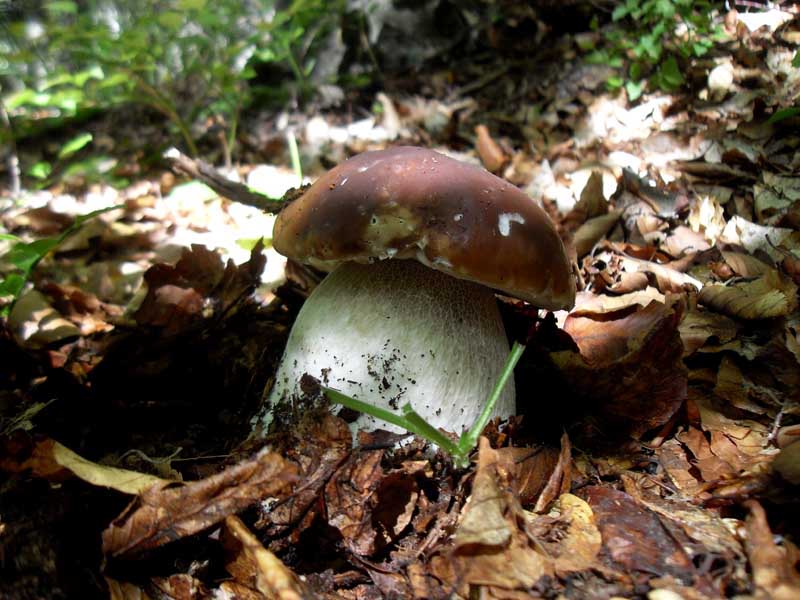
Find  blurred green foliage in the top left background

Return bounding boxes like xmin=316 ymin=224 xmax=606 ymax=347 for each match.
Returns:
xmin=0 ymin=0 xmax=343 ymax=159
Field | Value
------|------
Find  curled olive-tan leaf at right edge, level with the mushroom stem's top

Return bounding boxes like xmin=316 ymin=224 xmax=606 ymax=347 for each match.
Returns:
xmin=698 ymin=269 xmax=797 ymax=319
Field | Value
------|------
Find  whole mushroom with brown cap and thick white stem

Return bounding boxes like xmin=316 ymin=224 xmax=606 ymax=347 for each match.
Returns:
xmin=259 ymin=147 xmax=575 ymax=433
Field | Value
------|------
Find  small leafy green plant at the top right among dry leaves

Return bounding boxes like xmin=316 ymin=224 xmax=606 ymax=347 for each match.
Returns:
xmin=588 ymin=0 xmax=724 ymax=101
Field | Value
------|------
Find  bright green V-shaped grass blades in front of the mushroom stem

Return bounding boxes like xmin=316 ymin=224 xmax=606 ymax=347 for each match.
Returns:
xmin=322 ymin=342 xmax=525 ymax=468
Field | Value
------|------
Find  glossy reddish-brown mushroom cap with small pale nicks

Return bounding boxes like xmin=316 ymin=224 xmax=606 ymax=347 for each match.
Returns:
xmin=272 ymin=146 xmax=575 ymax=310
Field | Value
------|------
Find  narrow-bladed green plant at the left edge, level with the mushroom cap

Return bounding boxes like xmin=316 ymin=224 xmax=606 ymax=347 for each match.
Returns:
xmin=0 ymin=205 xmax=124 ymax=315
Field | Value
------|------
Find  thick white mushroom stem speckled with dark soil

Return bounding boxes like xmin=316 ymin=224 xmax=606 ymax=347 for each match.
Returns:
xmin=260 ymin=260 xmax=515 ymax=433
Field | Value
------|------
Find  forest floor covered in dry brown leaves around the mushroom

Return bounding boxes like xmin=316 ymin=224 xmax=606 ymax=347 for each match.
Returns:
xmin=0 ymin=5 xmax=800 ymax=600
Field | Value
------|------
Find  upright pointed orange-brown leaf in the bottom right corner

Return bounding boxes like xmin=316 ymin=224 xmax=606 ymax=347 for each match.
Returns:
xmin=745 ymin=500 xmax=800 ymax=600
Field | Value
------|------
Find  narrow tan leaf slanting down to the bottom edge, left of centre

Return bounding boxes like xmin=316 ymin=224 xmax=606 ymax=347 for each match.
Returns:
xmin=222 ymin=515 xmax=316 ymax=600
